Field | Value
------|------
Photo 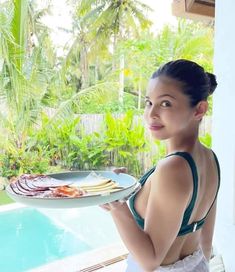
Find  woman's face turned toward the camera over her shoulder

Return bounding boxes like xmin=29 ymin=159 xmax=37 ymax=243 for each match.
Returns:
xmin=144 ymin=76 xmax=195 ymax=140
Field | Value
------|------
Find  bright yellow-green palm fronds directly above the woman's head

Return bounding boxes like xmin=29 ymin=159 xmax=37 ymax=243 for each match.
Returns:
xmin=117 ymin=19 xmax=213 ymax=108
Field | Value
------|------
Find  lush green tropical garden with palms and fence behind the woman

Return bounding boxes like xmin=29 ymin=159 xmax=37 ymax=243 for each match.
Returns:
xmin=0 ymin=0 xmax=214 ymax=204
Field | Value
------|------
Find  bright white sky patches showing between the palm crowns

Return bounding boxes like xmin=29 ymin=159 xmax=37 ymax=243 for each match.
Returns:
xmin=42 ymin=0 xmax=176 ymax=54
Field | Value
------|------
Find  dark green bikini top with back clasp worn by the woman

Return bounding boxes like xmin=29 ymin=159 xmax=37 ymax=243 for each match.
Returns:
xmin=129 ymin=151 xmax=220 ymax=236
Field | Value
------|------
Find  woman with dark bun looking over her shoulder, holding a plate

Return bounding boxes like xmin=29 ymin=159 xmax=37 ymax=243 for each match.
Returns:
xmin=102 ymin=59 xmax=220 ymax=272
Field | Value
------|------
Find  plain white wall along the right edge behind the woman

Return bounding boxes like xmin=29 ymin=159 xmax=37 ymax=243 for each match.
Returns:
xmin=212 ymin=0 xmax=235 ymax=272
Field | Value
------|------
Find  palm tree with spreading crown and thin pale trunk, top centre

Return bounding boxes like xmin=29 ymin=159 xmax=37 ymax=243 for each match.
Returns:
xmin=74 ymin=0 xmax=151 ymax=102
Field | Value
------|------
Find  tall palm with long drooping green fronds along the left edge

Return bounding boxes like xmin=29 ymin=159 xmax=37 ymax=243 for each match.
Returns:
xmin=0 ymin=0 xmax=58 ymax=174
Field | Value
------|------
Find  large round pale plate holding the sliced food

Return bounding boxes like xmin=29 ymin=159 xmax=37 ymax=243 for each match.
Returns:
xmin=6 ymin=171 xmax=139 ymax=209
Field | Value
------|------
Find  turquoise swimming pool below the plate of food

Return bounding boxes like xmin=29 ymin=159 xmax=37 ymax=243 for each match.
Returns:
xmin=0 ymin=207 xmax=120 ymax=272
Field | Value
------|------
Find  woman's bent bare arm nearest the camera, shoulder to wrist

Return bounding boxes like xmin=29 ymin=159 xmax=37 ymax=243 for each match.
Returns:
xmin=106 ymin=157 xmax=193 ymax=271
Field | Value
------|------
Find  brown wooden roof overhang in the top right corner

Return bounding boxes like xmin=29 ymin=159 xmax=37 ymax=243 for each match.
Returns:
xmin=172 ymin=0 xmax=215 ymax=22
